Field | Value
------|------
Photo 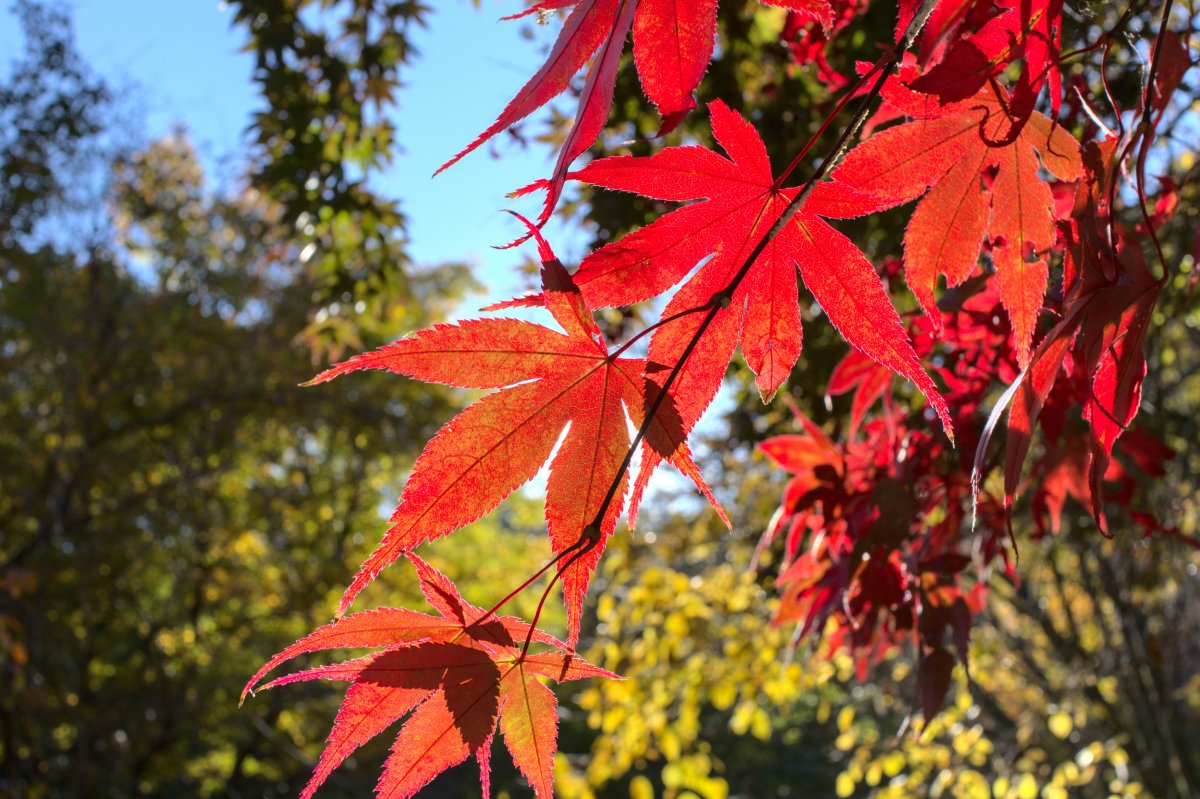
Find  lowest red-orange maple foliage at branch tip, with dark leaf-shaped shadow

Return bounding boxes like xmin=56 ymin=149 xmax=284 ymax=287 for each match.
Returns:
xmin=242 ymin=554 xmax=620 ymax=799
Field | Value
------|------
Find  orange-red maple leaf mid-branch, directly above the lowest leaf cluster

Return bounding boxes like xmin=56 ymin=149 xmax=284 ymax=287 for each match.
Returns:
xmin=312 ymin=220 xmax=716 ymax=645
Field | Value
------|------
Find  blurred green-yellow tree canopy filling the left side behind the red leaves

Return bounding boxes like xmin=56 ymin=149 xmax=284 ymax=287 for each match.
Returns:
xmin=0 ymin=1 xmax=549 ymax=797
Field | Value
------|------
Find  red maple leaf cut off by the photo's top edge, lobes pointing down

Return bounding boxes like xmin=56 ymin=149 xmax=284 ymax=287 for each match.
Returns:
xmin=438 ymin=0 xmax=833 ymax=224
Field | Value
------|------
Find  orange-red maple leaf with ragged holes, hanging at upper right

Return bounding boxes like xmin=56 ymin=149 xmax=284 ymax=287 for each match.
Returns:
xmin=834 ymin=77 xmax=1084 ymax=367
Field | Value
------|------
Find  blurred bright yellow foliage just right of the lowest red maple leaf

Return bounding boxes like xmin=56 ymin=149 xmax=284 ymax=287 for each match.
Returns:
xmin=560 ymin=506 xmax=834 ymax=799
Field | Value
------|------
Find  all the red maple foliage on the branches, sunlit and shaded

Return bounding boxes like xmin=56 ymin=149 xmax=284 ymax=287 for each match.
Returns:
xmin=248 ymin=0 xmax=1193 ymax=797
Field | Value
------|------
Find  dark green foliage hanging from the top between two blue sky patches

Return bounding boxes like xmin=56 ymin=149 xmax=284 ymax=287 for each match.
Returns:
xmin=229 ymin=0 xmax=430 ymax=358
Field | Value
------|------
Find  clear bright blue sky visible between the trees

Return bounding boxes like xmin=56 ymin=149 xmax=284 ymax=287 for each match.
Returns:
xmin=0 ymin=0 xmax=586 ymax=296
